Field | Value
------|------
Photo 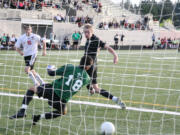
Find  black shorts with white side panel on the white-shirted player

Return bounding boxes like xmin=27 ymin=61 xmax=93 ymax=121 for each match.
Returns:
xmin=24 ymin=54 xmax=37 ymax=70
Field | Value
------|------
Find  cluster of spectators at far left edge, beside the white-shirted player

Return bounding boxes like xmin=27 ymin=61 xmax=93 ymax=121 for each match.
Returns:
xmin=0 ymin=33 xmax=17 ymax=49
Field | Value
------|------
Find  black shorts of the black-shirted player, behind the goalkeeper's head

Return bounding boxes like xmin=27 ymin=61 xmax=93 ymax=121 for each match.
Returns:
xmin=87 ymin=63 xmax=97 ymax=84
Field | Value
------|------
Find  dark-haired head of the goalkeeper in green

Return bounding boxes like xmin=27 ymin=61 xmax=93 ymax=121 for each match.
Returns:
xmin=79 ymin=55 xmax=93 ymax=70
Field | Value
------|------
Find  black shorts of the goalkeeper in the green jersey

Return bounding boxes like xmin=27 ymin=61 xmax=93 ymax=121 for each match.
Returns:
xmin=37 ymin=84 xmax=66 ymax=112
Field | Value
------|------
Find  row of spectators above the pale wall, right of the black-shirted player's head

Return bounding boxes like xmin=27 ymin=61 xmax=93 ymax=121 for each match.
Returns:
xmin=98 ymin=18 xmax=150 ymax=30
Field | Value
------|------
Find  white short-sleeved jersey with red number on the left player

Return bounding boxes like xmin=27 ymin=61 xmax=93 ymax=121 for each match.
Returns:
xmin=15 ymin=33 xmax=41 ymax=56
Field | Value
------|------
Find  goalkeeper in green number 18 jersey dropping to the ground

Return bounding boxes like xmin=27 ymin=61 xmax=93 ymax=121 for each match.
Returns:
xmin=10 ymin=56 xmax=93 ymax=125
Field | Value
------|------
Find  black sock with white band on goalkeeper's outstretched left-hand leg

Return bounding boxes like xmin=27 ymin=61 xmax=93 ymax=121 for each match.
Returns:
xmin=21 ymin=90 xmax=34 ymax=109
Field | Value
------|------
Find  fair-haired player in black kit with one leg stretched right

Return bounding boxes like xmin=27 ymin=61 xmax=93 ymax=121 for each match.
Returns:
xmin=83 ymin=24 xmax=126 ymax=109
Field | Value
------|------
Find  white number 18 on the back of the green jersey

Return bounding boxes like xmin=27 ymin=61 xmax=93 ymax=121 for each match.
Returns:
xmin=65 ymin=75 xmax=83 ymax=91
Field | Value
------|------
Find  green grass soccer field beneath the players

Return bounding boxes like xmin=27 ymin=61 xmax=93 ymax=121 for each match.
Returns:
xmin=0 ymin=50 xmax=180 ymax=135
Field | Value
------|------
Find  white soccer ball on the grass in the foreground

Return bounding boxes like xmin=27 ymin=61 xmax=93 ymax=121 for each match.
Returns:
xmin=101 ymin=122 xmax=115 ymax=135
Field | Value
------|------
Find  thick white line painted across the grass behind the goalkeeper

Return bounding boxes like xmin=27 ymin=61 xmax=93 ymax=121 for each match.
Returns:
xmin=0 ymin=92 xmax=180 ymax=116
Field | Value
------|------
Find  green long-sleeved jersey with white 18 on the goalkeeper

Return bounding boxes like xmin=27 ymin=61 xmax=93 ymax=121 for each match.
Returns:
xmin=52 ymin=64 xmax=90 ymax=103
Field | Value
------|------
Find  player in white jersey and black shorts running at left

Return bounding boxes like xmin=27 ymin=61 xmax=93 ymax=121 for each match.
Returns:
xmin=15 ymin=26 xmax=46 ymax=86
